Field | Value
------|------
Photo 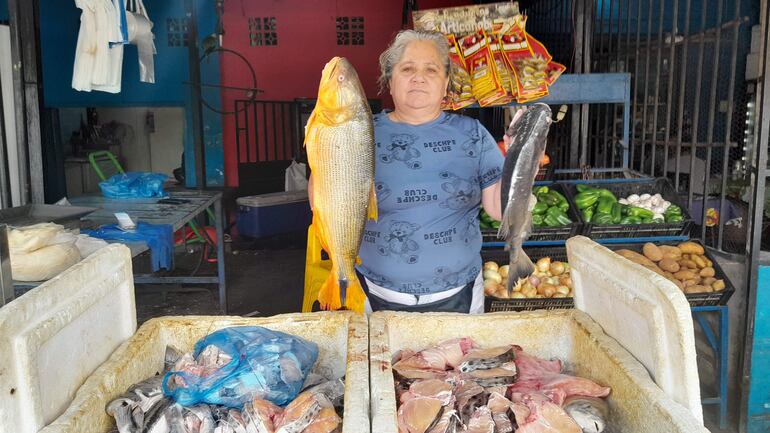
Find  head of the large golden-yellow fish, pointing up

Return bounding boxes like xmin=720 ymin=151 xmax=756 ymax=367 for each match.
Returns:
xmin=315 ymin=57 xmax=371 ymax=125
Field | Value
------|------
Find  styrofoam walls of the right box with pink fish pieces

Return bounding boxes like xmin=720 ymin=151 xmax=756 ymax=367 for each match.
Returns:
xmin=369 ymin=310 xmax=708 ymax=433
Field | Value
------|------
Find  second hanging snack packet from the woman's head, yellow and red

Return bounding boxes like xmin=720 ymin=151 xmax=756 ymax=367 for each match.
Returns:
xmin=460 ymin=29 xmax=505 ymax=106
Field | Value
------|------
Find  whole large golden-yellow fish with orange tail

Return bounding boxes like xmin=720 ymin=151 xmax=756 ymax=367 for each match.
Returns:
xmin=305 ymin=57 xmax=377 ymax=312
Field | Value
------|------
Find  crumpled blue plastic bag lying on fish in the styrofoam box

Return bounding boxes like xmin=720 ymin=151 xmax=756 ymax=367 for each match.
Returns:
xmin=163 ymin=326 xmax=318 ymax=408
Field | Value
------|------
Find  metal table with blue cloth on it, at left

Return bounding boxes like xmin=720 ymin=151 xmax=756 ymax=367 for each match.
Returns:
xmin=70 ymin=190 xmax=227 ymax=314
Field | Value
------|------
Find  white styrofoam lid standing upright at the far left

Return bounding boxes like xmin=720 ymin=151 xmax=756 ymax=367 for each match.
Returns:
xmin=0 ymin=244 xmax=136 ymax=433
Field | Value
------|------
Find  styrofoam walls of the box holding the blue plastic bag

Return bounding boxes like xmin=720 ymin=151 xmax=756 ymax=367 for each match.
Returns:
xmin=41 ymin=312 xmax=369 ymax=433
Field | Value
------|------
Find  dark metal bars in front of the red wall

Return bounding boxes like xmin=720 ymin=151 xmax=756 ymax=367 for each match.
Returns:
xmin=235 ymin=100 xmax=302 ymax=163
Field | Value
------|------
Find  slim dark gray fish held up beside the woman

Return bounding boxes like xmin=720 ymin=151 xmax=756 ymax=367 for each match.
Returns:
xmin=497 ymin=104 xmax=551 ymax=294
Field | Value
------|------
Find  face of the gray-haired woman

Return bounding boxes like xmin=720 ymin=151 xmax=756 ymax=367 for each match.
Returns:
xmin=390 ymin=41 xmax=449 ymax=110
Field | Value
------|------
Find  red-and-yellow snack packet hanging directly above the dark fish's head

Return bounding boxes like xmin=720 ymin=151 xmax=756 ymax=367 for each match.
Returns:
xmin=502 ymin=24 xmax=548 ymax=104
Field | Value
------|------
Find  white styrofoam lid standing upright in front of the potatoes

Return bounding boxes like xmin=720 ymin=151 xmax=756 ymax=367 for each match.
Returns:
xmin=567 ymin=236 xmax=703 ymax=423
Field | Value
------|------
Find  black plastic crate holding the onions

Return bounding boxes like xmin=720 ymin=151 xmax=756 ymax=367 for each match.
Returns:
xmin=481 ymin=247 xmax=575 ymax=313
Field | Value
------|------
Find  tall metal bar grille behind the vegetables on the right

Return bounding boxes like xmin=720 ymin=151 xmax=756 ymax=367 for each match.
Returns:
xmin=523 ymin=0 xmax=756 ymax=253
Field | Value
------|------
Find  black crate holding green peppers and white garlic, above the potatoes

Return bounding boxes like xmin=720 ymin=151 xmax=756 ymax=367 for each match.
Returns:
xmin=565 ymin=178 xmax=693 ymax=239
